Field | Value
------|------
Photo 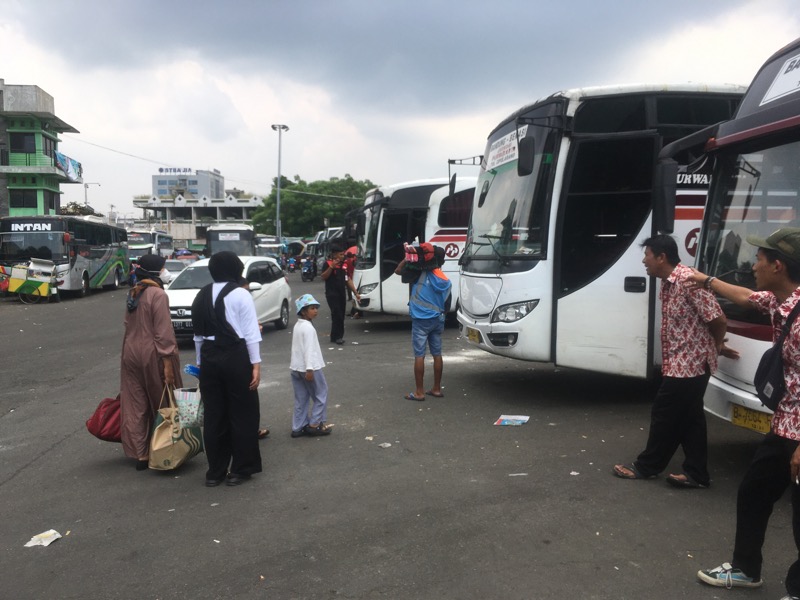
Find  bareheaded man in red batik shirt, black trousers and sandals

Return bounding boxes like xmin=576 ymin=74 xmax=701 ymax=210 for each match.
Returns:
xmin=613 ymin=235 xmax=738 ymax=488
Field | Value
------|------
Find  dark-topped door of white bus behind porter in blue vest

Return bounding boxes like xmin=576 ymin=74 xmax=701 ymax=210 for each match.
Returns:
xmin=378 ymin=207 xmax=428 ymax=314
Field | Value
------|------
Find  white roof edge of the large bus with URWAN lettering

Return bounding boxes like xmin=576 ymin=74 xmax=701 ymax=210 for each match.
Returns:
xmin=489 ymin=82 xmax=747 ymax=136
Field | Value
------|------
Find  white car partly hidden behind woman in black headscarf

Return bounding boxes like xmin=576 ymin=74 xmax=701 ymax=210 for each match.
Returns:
xmin=166 ymin=256 xmax=292 ymax=337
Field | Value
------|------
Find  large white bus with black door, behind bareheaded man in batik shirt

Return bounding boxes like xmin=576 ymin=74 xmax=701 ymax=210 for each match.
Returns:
xmin=458 ymin=84 xmax=744 ymax=378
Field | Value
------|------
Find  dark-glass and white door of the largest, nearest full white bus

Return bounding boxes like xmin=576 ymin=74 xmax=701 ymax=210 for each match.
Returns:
xmin=553 ymin=132 xmax=660 ymax=378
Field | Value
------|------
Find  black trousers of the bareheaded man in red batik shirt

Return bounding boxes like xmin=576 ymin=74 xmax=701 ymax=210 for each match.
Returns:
xmin=635 ymin=372 xmax=711 ymax=485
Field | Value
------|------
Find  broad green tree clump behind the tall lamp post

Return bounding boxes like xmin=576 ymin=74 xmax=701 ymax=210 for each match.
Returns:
xmin=253 ymin=175 xmax=377 ymax=237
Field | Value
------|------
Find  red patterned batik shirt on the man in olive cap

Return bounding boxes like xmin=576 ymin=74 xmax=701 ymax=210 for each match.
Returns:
xmin=748 ymin=288 xmax=800 ymax=440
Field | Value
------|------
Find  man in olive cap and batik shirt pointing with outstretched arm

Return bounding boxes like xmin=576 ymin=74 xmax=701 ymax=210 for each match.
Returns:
xmin=692 ymin=227 xmax=800 ymax=600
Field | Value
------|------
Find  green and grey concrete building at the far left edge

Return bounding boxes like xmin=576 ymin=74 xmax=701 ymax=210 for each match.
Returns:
xmin=0 ymin=79 xmax=83 ymax=216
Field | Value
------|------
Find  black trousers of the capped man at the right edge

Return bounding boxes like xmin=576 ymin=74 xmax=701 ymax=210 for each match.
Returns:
xmin=731 ymin=432 xmax=800 ymax=596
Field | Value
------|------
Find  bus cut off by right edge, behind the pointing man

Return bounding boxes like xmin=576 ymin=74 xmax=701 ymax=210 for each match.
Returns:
xmin=659 ymin=39 xmax=800 ymax=433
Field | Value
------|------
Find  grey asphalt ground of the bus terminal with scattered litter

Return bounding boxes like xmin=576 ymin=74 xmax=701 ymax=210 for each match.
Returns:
xmin=0 ymin=273 xmax=794 ymax=600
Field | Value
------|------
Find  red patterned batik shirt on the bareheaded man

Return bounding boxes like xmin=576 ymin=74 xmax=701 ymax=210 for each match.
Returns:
xmin=660 ymin=264 xmax=722 ymax=378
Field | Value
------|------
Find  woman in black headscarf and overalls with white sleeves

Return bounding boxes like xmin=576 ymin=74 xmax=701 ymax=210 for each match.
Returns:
xmin=192 ymin=252 xmax=261 ymax=487
